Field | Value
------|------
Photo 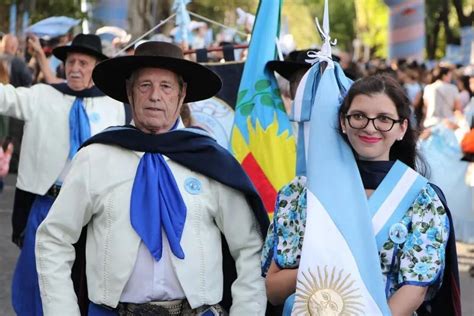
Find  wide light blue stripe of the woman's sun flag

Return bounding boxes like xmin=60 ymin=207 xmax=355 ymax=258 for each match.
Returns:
xmin=307 ymin=64 xmax=390 ymax=315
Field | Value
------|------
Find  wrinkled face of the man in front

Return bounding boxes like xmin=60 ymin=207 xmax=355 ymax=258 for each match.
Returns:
xmin=127 ymin=68 xmax=186 ymax=134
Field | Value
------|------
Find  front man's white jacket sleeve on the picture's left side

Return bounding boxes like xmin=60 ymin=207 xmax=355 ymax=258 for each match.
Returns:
xmin=35 ymin=148 xmax=92 ymax=315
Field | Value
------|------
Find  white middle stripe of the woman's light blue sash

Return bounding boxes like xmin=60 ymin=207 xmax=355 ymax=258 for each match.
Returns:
xmin=372 ymin=168 xmax=418 ymax=236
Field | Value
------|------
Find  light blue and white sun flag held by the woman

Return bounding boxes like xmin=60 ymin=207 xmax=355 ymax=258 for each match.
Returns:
xmin=292 ymin=0 xmax=390 ymax=315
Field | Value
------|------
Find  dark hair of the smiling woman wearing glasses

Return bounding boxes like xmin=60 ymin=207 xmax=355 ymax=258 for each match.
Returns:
xmin=339 ymin=74 xmax=428 ymax=174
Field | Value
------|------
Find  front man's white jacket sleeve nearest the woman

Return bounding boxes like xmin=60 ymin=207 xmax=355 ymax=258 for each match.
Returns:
xmin=216 ymin=184 xmax=267 ymax=315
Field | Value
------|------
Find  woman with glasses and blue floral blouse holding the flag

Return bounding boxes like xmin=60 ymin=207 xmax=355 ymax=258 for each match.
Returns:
xmin=262 ymin=75 xmax=460 ymax=315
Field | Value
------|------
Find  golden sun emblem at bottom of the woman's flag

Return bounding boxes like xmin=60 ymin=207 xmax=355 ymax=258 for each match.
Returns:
xmin=294 ymin=266 xmax=364 ymax=316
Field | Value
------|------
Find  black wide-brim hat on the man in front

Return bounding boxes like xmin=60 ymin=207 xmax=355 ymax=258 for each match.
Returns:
xmin=92 ymin=41 xmax=222 ymax=103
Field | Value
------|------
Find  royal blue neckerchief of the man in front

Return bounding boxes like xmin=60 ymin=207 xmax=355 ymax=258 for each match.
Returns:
xmin=130 ymin=153 xmax=186 ymax=261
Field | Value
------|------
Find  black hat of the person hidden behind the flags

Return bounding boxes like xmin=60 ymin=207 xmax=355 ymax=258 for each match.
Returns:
xmin=267 ymin=49 xmax=339 ymax=81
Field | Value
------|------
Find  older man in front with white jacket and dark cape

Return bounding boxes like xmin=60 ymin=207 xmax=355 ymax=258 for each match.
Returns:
xmin=36 ymin=42 xmax=268 ymax=315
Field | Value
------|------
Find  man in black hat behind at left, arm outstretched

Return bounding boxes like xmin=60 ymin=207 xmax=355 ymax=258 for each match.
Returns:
xmin=0 ymin=34 xmax=125 ymax=315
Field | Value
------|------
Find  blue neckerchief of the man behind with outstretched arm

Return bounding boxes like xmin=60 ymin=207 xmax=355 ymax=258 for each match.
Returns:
xmin=69 ymin=97 xmax=91 ymax=159
